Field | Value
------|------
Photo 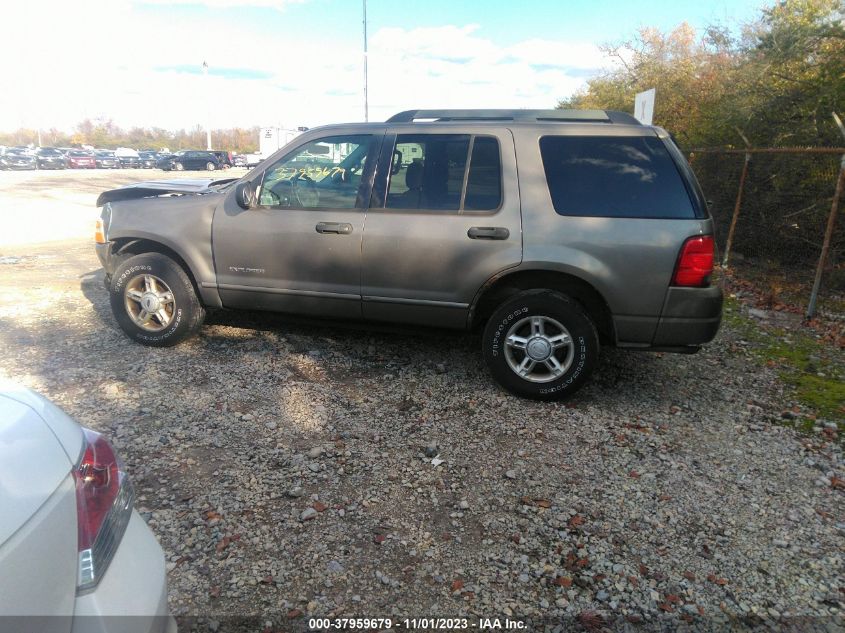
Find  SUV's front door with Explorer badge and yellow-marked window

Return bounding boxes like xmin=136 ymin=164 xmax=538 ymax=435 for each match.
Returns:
xmin=212 ymin=133 xmax=382 ymax=318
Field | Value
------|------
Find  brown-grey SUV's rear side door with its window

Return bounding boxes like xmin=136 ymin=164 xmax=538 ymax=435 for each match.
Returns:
xmin=361 ymin=124 xmax=522 ymax=328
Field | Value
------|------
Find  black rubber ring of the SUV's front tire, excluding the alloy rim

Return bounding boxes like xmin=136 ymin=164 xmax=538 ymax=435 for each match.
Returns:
xmin=109 ymin=253 xmax=201 ymax=347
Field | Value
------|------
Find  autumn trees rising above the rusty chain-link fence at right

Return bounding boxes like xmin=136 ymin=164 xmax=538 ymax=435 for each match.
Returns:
xmin=558 ymin=0 xmax=845 ymax=148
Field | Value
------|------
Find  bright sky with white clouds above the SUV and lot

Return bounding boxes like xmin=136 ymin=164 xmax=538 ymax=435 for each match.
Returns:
xmin=0 ymin=0 xmax=767 ymax=131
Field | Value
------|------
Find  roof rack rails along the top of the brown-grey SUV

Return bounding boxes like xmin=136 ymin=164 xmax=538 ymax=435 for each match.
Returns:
xmin=387 ymin=110 xmax=640 ymax=125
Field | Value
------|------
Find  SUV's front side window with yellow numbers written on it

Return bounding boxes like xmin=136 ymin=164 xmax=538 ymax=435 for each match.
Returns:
xmin=259 ymin=134 xmax=375 ymax=209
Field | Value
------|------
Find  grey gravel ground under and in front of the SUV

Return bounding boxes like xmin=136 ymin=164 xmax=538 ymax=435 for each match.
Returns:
xmin=0 ymin=242 xmax=845 ymax=630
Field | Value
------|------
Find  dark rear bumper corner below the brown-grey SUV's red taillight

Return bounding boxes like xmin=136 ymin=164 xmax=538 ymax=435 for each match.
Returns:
xmin=652 ymin=286 xmax=722 ymax=348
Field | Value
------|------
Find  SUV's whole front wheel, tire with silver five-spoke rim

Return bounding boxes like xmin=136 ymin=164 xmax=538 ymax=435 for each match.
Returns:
xmin=109 ymin=253 xmax=205 ymax=347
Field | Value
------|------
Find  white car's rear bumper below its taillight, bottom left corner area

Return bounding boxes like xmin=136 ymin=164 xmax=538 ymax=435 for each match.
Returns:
xmin=72 ymin=511 xmax=176 ymax=633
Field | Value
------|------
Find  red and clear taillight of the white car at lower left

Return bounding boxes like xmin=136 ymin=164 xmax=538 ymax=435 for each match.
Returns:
xmin=73 ymin=429 xmax=134 ymax=591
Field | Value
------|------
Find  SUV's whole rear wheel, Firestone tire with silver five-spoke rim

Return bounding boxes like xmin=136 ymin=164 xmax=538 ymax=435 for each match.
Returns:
xmin=481 ymin=289 xmax=599 ymax=400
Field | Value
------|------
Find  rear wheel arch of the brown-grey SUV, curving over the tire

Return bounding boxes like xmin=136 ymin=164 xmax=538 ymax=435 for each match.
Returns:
xmin=469 ymin=269 xmax=616 ymax=344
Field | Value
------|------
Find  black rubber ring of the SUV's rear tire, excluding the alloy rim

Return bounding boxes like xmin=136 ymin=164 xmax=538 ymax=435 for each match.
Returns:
xmin=482 ymin=291 xmax=599 ymax=400
